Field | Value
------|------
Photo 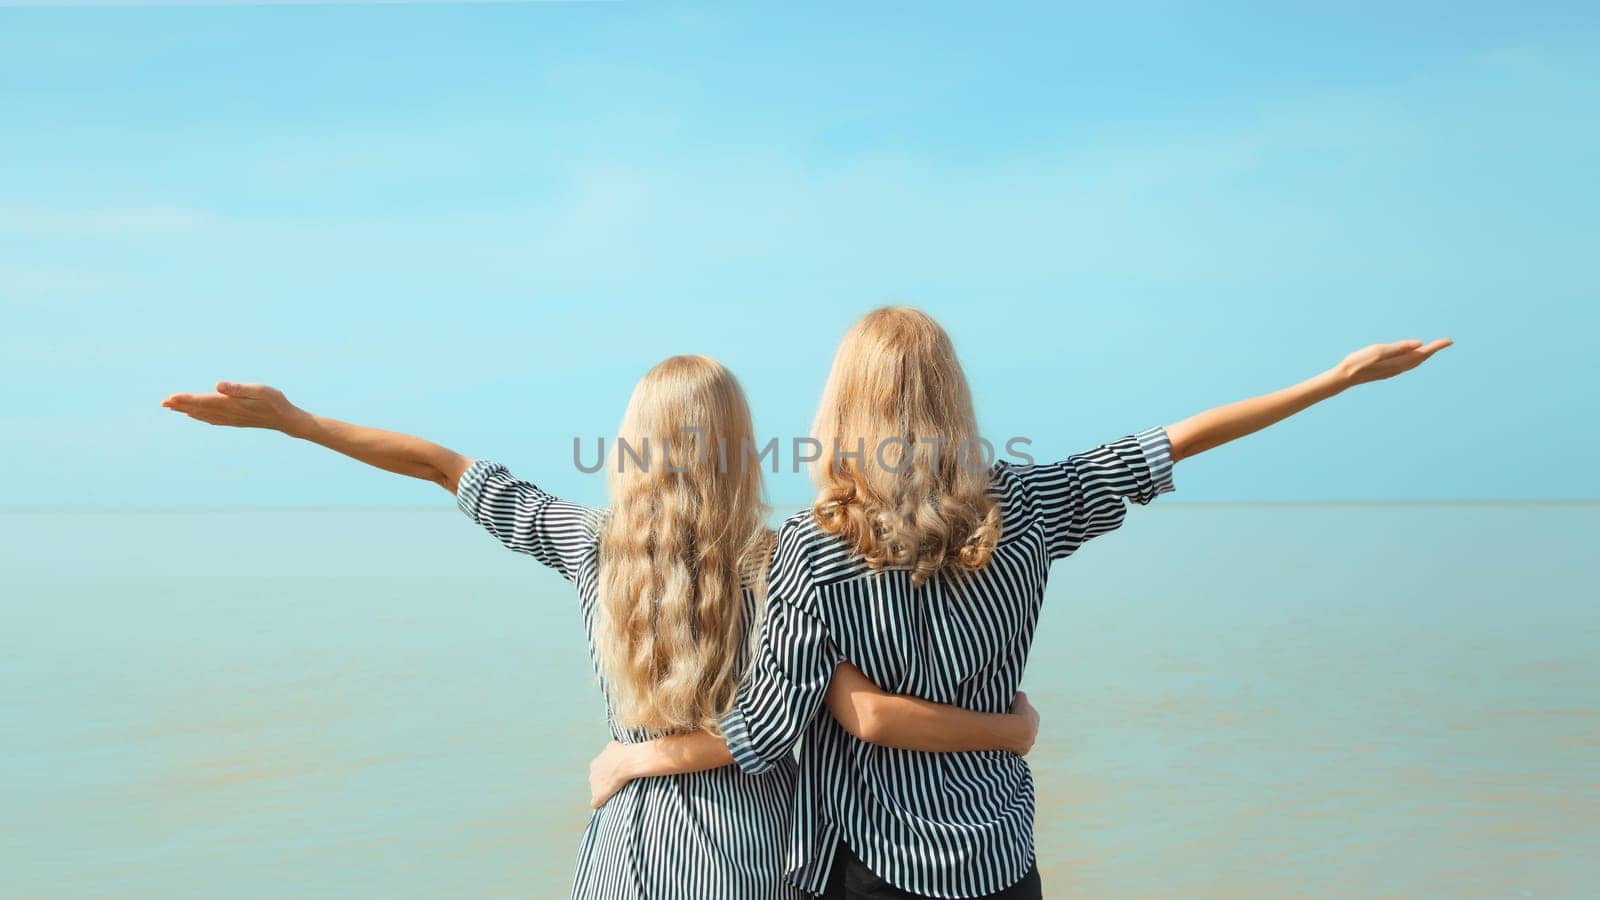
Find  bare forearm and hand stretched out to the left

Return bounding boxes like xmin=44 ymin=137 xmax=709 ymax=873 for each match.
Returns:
xmin=162 ymin=381 xmax=472 ymax=493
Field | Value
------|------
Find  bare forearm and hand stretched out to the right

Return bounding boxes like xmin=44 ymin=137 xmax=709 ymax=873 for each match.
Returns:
xmin=1166 ymin=338 xmax=1451 ymax=463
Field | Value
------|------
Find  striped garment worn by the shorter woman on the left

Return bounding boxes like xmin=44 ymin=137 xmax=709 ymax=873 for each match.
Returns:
xmin=456 ymin=460 xmax=802 ymax=900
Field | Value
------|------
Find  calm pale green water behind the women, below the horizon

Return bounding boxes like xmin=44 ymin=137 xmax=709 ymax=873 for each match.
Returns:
xmin=0 ymin=503 xmax=1600 ymax=898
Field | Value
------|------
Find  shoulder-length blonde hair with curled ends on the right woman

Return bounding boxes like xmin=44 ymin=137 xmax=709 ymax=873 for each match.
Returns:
xmin=811 ymin=306 xmax=1000 ymax=585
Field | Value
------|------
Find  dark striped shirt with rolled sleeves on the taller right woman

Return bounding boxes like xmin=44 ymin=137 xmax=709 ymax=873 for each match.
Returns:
xmin=722 ymin=428 xmax=1173 ymax=897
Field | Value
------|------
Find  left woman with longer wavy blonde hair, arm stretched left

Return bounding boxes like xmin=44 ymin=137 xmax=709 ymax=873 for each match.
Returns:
xmin=162 ymin=356 xmax=1037 ymax=900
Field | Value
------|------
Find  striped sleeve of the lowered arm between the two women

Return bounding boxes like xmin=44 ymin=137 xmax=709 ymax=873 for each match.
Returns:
xmin=720 ymin=525 xmax=842 ymax=773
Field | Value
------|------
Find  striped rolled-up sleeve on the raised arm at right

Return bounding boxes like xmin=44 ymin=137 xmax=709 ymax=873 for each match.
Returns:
xmin=1018 ymin=428 xmax=1173 ymax=559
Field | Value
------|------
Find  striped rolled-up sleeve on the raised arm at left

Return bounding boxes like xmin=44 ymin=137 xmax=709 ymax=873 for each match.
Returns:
xmin=456 ymin=460 xmax=600 ymax=581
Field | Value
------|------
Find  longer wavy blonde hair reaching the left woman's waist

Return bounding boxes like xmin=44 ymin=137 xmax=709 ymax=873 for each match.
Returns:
xmin=595 ymin=356 xmax=771 ymax=733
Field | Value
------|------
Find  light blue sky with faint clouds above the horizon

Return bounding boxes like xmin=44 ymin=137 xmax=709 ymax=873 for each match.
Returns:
xmin=0 ymin=0 xmax=1600 ymax=508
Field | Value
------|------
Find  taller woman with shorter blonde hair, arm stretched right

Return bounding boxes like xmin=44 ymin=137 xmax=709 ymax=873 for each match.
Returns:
xmin=592 ymin=307 xmax=1450 ymax=900
